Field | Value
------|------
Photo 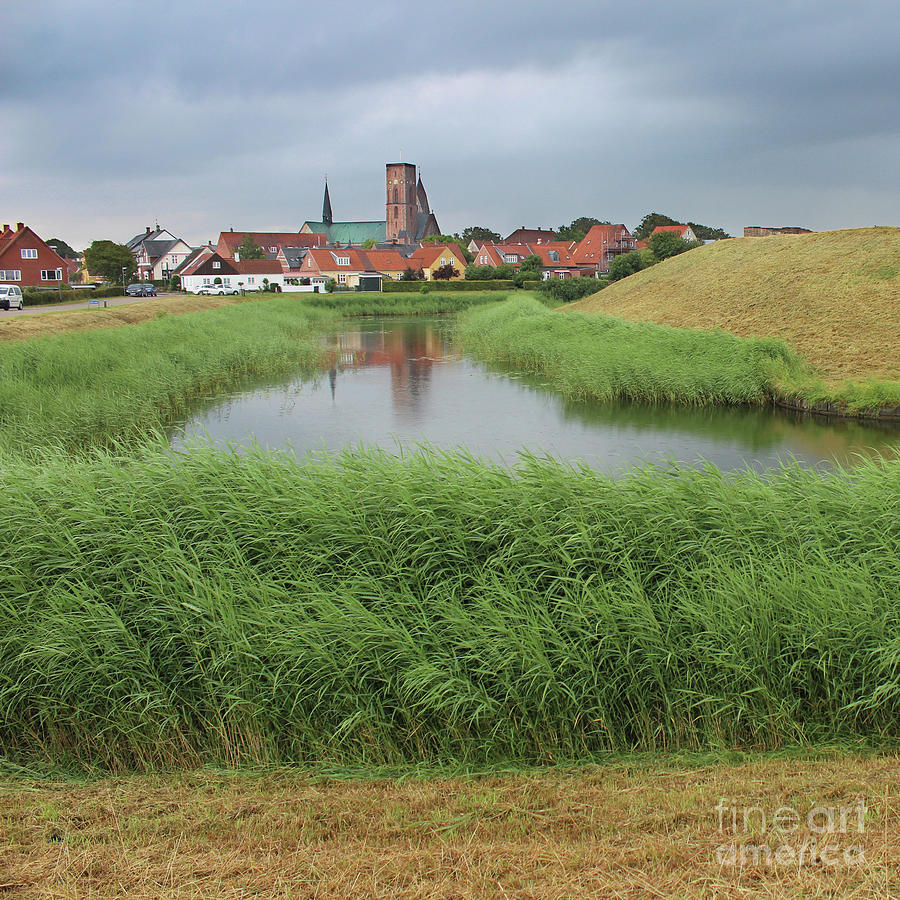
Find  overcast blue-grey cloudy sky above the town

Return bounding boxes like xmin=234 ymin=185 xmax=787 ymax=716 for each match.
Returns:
xmin=0 ymin=0 xmax=900 ymax=250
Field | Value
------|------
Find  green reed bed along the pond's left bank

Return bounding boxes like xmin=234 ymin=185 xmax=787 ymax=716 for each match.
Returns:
xmin=0 ymin=298 xmax=336 ymax=453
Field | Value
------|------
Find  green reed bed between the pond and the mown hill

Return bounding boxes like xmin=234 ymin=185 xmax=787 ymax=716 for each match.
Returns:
xmin=458 ymin=298 xmax=802 ymax=406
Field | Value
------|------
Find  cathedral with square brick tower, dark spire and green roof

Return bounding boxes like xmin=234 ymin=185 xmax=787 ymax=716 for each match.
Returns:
xmin=300 ymin=163 xmax=441 ymax=246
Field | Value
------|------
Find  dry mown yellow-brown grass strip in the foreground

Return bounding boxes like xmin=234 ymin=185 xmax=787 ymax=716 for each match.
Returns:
xmin=0 ymin=758 xmax=900 ymax=898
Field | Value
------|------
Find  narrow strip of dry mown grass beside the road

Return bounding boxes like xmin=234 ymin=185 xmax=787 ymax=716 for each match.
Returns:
xmin=0 ymin=294 xmax=273 ymax=341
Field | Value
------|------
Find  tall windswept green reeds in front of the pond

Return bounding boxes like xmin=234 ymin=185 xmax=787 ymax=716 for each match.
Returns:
xmin=0 ymin=447 xmax=900 ymax=771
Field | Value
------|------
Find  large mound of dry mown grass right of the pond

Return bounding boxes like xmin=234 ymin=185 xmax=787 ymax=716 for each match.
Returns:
xmin=567 ymin=228 xmax=900 ymax=382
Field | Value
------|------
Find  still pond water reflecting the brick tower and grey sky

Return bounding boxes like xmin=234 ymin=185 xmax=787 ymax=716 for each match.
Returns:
xmin=172 ymin=318 xmax=900 ymax=471
